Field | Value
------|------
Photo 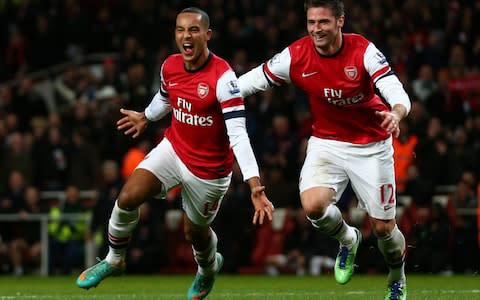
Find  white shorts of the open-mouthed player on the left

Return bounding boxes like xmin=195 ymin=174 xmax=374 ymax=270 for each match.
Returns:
xmin=137 ymin=138 xmax=232 ymax=226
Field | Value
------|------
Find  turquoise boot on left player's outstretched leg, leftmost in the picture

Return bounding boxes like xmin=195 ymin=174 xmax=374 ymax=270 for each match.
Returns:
xmin=77 ymin=258 xmax=125 ymax=290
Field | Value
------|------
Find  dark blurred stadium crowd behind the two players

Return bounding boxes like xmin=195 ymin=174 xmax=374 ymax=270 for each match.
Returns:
xmin=0 ymin=0 xmax=480 ymax=275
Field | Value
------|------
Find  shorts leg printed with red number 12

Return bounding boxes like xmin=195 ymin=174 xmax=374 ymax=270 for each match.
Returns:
xmin=347 ymin=139 xmax=396 ymax=220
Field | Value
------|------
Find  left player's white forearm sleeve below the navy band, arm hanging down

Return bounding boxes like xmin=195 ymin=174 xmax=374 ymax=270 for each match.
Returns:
xmin=225 ymin=117 xmax=260 ymax=181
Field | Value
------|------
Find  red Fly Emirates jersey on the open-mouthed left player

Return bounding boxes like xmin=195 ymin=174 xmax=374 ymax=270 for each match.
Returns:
xmin=161 ymin=54 xmax=244 ymax=179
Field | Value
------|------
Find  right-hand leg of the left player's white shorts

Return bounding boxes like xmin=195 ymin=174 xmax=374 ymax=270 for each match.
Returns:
xmin=182 ymin=167 xmax=232 ymax=226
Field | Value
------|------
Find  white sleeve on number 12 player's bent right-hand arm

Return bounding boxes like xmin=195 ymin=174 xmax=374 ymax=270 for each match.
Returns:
xmin=364 ymin=43 xmax=411 ymax=114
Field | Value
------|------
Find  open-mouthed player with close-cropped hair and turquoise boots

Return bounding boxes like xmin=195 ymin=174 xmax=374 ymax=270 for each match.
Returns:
xmin=77 ymin=7 xmax=274 ymax=299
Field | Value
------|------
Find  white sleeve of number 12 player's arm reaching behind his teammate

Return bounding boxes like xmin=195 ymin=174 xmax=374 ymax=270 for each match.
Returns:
xmin=238 ymin=48 xmax=292 ymax=97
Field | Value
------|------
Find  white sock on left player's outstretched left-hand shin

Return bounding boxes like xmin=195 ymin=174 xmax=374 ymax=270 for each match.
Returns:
xmin=105 ymin=201 xmax=140 ymax=265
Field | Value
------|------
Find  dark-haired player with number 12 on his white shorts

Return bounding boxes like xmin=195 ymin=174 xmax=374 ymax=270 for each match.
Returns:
xmin=239 ymin=0 xmax=410 ymax=299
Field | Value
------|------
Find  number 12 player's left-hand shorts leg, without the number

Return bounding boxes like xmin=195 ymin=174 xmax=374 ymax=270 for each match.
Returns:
xmin=299 ymin=137 xmax=348 ymax=202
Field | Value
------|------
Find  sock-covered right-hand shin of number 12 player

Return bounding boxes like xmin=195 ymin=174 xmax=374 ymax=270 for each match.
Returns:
xmin=377 ymin=225 xmax=406 ymax=282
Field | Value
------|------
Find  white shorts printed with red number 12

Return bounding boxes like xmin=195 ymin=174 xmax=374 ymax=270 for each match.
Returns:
xmin=299 ymin=137 xmax=396 ymax=220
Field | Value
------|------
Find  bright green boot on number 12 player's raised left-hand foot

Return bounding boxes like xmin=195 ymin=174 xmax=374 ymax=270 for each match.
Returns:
xmin=334 ymin=228 xmax=362 ymax=284
